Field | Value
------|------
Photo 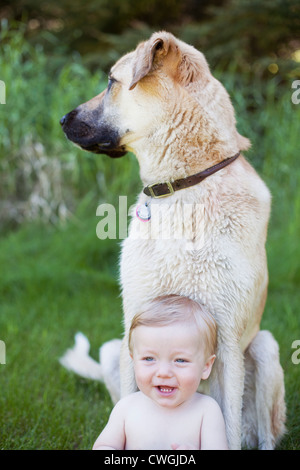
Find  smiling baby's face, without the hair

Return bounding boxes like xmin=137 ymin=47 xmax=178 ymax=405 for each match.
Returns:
xmin=132 ymin=323 xmax=213 ymax=408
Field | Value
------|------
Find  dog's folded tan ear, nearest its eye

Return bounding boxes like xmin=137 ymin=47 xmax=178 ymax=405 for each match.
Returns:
xmin=129 ymin=33 xmax=169 ymax=90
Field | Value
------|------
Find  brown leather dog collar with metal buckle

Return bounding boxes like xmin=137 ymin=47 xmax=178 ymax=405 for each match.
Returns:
xmin=143 ymin=152 xmax=240 ymax=199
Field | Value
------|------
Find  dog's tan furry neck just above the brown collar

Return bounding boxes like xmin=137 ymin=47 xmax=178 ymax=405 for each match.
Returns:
xmin=132 ymin=97 xmax=240 ymax=186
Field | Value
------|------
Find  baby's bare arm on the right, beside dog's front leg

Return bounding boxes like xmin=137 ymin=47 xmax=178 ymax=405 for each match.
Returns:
xmin=201 ymin=397 xmax=228 ymax=450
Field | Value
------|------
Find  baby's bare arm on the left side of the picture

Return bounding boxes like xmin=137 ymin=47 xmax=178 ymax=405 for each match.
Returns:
xmin=93 ymin=400 xmax=126 ymax=450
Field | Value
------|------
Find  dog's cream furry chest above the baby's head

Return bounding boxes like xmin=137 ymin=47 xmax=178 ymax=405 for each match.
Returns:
xmin=121 ymin=196 xmax=249 ymax=324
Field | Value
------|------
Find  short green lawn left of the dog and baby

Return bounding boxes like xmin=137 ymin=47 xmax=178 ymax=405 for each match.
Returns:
xmin=0 ymin=218 xmax=122 ymax=449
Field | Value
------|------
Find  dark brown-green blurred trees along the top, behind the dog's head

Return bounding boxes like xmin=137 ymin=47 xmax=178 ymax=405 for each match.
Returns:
xmin=0 ymin=0 xmax=300 ymax=74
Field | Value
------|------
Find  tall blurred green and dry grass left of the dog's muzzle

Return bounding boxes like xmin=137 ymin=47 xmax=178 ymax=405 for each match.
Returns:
xmin=0 ymin=24 xmax=137 ymax=229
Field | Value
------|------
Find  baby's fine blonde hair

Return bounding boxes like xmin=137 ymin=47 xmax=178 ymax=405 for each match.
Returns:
xmin=128 ymin=294 xmax=217 ymax=356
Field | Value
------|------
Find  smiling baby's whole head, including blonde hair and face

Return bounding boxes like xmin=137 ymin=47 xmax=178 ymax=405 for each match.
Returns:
xmin=129 ymin=295 xmax=217 ymax=407
